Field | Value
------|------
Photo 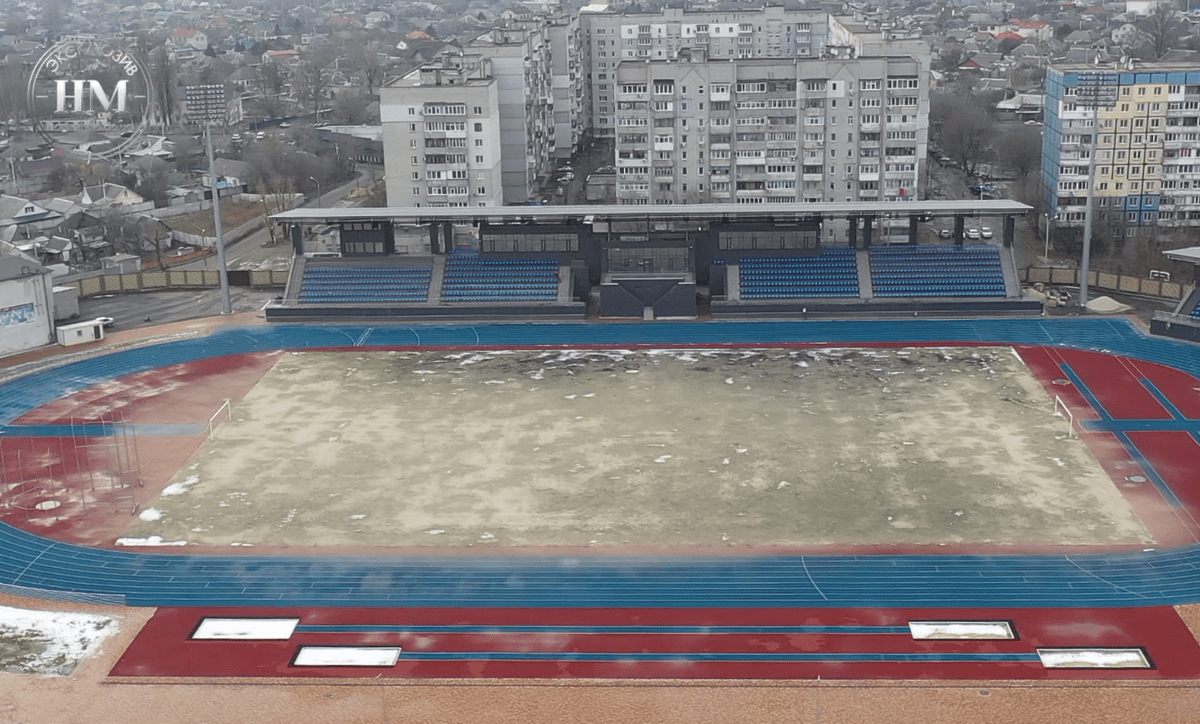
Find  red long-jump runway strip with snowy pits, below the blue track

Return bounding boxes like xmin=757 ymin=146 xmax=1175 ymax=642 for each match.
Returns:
xmin=109 ymin=608 xmax=1200 ymax=680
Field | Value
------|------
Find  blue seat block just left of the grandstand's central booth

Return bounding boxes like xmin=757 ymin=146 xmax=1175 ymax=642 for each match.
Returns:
xmin=442 ymin=251 xmax=558 ymax=301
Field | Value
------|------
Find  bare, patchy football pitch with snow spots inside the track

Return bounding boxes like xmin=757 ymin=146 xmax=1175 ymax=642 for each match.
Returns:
xmin=127 ymin=347 xmax=1150 ymax=548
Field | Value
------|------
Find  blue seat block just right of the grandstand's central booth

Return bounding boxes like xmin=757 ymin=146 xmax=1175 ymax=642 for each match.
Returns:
xmin=738 ymin=246 xmax=858 ymax=299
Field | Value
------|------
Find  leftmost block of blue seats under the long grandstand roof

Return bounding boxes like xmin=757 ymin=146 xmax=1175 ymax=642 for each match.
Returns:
xmin=299 ymin=265 xmax=432 ymax=304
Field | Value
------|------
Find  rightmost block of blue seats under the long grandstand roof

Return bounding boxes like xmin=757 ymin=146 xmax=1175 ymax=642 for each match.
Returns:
xmin=870 ymin=244 xmax=1006 ymax=297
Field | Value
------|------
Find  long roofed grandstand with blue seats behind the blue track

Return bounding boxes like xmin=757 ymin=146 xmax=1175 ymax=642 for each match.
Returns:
xmin=266 ymin=201 xmax=1042 ymax=321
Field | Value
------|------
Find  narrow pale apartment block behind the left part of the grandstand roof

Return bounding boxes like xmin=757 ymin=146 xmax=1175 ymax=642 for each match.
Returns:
xmin=379 ymin=54 xmax=504 ymax=207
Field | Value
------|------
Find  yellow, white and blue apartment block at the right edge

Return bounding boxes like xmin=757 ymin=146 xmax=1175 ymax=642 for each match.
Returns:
xmin=1042 ymin=62 xmax=1200 ymax=240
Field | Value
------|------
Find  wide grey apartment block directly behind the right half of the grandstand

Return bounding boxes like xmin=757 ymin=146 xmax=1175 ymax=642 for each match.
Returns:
xmin=613 ymin=52 xmax=929 ymax=213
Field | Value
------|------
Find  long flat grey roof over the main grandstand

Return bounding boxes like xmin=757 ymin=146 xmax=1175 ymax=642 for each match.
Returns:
xmin=271 ymin=199 xmax=1032 ymax=223
